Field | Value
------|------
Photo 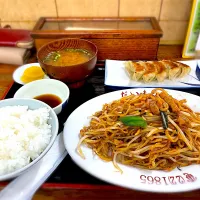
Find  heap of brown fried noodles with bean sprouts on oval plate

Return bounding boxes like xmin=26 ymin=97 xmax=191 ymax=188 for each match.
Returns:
xmin=77 ymin=89 xmax=200 ymax=171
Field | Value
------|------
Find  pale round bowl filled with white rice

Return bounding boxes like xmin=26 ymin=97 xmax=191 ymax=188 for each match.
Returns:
xmin=0 ymin=98 xmax=59 ymax=181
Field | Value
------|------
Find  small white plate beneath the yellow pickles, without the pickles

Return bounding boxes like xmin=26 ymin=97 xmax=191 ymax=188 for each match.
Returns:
xmin=13 ymin=63 xmax=49 ymax=85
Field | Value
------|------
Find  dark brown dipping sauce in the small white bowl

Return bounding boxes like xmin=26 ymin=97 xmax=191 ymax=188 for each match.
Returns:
xmin=34 ymin=94 xmax=62 ymax=108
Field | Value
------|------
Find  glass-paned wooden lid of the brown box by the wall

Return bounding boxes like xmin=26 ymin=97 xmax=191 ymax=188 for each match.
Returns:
xmin=31 ymin=17 xmax=162 ymax=39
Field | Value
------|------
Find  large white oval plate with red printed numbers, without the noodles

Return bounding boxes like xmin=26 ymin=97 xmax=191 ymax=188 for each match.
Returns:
xmin=64 ymin=88 xmax=200 ymax=192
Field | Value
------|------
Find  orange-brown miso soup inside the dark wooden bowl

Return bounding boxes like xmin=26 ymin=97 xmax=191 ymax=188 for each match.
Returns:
xmin=43 ymin=48 xmax=92 ymax=66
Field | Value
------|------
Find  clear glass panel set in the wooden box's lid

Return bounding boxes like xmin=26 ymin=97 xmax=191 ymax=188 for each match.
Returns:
xmin=42 ymin=21 xmax=153 ymax=31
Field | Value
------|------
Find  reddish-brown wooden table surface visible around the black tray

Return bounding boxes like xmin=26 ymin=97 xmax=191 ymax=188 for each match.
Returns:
xmin=0 ymin=45 xmax=200 ymax=200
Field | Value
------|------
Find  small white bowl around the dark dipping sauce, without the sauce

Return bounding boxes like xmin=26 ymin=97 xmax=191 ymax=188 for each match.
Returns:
xmin=14 ymin=79 xmax=70 ymax=115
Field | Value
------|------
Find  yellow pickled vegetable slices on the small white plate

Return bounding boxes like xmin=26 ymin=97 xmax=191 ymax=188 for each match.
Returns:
xmin=20 ymin=66 xmax=45 ymax=83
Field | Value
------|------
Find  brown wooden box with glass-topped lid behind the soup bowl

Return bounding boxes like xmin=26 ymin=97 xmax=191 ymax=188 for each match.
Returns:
xmin=31 ymin=17 xmax=162 ymax=61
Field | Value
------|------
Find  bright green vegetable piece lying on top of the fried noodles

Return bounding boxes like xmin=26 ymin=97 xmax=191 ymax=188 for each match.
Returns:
xmin=119 ymin=116 xmax=147 ymax=128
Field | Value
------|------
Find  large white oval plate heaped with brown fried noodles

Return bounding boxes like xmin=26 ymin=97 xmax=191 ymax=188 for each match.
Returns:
xmin=64 ymin=88 xmax=200 ymax=192
